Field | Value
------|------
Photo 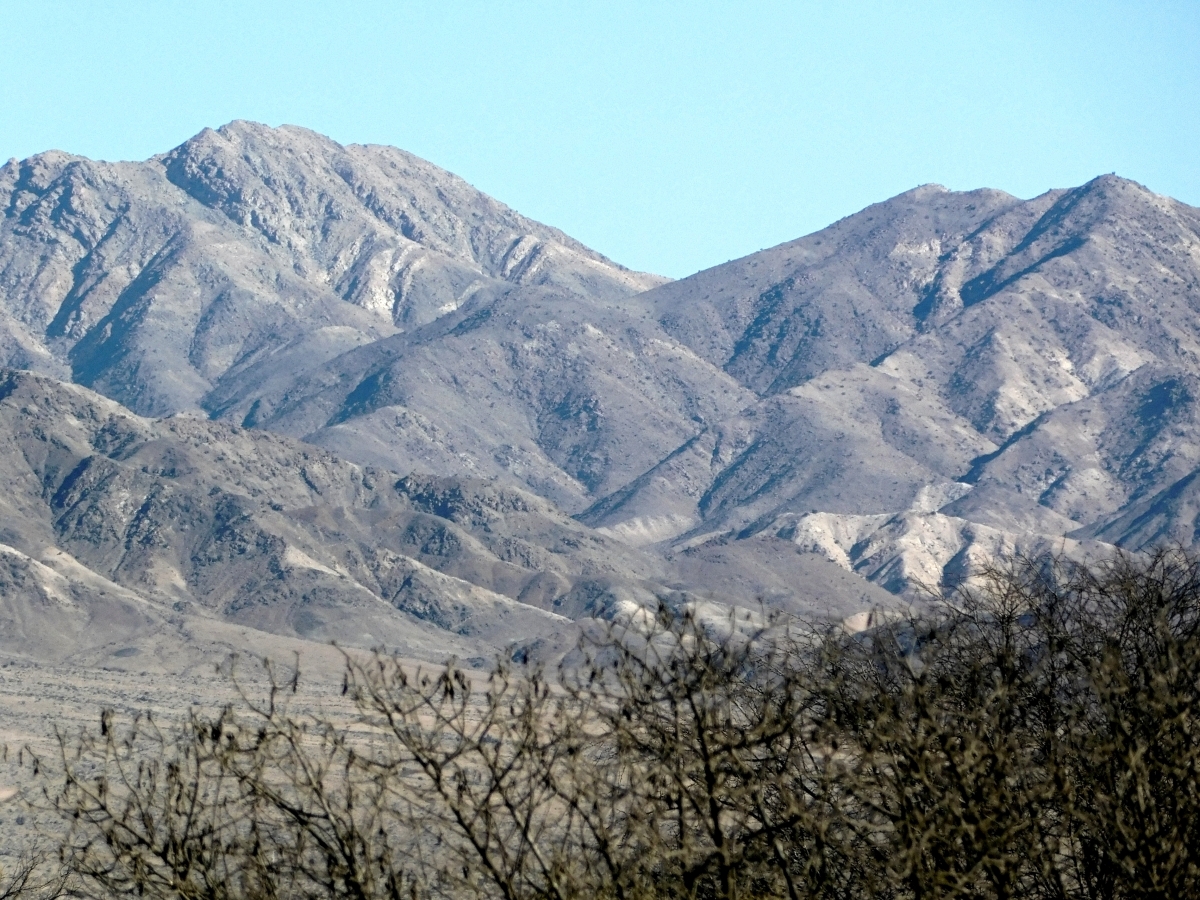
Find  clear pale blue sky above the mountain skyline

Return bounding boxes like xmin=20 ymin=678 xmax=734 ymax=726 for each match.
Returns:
xmin=0 ymin=0 xmax=1200 ymax=276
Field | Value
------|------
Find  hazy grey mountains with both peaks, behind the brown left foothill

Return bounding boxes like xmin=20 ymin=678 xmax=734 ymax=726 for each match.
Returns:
xmin=0 ymin=122 xmax=1200 ymax=643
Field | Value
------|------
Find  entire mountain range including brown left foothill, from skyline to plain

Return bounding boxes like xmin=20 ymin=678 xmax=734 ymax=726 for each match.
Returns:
xmin=0 ymin=122 xmax=1200 ymax=653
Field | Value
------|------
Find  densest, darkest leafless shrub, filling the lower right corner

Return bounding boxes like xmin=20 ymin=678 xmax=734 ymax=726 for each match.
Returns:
xmin=822 ymin=550 xmax=1200 ymax=898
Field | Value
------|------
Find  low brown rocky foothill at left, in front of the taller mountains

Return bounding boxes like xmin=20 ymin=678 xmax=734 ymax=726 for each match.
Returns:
xmin=0 ymin=370 xmax=883 ymax=660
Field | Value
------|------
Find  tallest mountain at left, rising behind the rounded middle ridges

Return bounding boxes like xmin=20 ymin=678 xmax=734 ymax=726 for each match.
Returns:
xmin=0 ymin=122 xmax=662 ymax=415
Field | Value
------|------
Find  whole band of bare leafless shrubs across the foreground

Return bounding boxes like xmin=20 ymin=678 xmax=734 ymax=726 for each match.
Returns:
xmin=23 ymin=551 xmax=1200 ymax=900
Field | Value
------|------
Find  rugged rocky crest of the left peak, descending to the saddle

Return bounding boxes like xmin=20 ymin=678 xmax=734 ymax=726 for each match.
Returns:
xmin=156 ymin=121 xmax=643 ymax=292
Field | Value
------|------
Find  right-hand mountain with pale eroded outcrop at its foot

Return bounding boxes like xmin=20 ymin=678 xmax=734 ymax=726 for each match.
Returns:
xmin=582 ymin=176 xmax=1200 ymax=589
